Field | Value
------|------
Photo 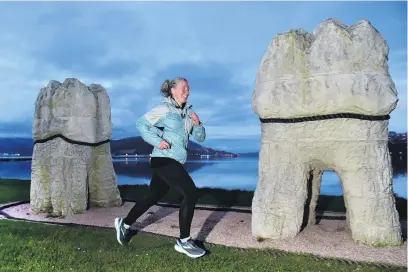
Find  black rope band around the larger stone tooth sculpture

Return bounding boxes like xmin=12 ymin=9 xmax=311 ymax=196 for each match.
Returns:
xmin=259 ymin=113 xmax=390 ymax=123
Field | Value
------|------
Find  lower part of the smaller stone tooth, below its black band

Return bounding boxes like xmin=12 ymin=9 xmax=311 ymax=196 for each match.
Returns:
xmin=30 ymin=138 xmax=122 ymax=216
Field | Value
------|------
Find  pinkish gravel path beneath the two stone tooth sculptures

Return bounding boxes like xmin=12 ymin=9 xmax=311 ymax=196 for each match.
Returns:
xmin=3 ymin=202 xmax=407 ymax=266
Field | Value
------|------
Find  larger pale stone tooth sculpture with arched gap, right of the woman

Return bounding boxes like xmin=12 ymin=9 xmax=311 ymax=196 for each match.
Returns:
xmin=252 ymin=20 xmax=401 ymax=245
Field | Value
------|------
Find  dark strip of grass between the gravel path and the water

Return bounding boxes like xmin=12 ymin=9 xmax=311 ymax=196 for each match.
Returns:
xmin=0 ymin=179 xmax=407 ymax=218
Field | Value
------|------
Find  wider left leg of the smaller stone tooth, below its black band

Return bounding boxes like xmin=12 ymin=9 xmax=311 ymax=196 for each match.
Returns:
xmin=30 ymin=138 xmax=92 ymax=216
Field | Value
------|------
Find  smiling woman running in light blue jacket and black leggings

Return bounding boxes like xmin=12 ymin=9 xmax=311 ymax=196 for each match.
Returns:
xmin=115 ymin=77 xmax=206 ymax=258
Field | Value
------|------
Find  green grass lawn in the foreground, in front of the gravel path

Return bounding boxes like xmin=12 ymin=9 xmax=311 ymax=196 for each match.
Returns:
xmin=0 ymin=220 xmax=406 ymax=272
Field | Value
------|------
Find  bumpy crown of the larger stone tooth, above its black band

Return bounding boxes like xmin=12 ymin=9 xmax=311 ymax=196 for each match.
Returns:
xmin=252 ymin=20 xmax=398 ymax=118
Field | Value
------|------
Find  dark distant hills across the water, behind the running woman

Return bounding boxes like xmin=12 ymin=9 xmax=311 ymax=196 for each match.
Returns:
xmin=0 ymin=136 xmax=237 ymax=157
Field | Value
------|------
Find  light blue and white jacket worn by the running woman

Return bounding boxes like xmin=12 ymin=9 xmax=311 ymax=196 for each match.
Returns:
xmin=136 ymin=97 xmax=206 ymax=164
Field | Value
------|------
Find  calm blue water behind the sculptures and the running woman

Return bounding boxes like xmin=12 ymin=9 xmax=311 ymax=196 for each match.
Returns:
xmin=0 ymin=158 xmax=407 ymax=198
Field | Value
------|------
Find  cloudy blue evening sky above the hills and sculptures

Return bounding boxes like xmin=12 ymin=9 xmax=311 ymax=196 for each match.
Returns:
xmin=0 ymin=1 xmax=407 ymax=152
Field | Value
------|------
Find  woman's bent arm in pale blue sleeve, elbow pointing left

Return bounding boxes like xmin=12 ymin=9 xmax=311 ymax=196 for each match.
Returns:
xmin=136 ymin=105 xmax=167 ymax=147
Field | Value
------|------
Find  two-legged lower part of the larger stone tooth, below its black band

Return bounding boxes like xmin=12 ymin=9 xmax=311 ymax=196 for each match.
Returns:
xmin=252 ymin=119 xmax=402 ymax=245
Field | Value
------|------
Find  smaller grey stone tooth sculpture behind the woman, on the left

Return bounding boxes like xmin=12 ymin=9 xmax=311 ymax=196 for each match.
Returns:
xmin=30 ymin=79 xmax=122 ymax=216
